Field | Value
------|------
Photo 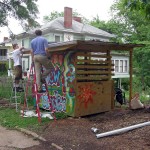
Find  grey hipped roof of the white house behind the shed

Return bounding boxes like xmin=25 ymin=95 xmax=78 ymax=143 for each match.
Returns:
xmin=26 ymin=17 xmax=115 ymax=38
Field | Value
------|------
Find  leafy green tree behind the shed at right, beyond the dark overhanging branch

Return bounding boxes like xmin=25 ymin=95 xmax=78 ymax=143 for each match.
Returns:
xmin=112 ymin=0 xmax=150 ymax=90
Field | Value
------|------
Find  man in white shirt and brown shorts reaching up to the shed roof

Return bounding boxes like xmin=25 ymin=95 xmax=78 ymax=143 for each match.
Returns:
xmin=12 ymin=44 xmax=24 ymax=92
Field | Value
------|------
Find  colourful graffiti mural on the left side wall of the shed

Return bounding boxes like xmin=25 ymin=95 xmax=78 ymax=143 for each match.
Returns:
xmin=41 ymin=53 xmax=75 ymax=113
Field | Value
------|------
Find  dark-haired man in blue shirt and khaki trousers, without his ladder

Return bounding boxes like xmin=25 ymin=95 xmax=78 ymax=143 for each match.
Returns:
xmin=31 ymin=30 xmax=53 ymax=93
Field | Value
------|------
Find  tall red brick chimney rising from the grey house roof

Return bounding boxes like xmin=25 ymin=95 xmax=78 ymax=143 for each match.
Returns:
xmin=64 ymin=7 xmax=72 ymax=28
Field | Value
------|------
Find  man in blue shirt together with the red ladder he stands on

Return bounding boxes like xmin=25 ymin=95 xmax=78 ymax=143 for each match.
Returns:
xmin=28 ymin=30 xmax=55 ymax=122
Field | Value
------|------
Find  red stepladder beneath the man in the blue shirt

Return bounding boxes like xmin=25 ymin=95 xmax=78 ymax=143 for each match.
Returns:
xmin=23 ymin=63 xmax=56 ymax=122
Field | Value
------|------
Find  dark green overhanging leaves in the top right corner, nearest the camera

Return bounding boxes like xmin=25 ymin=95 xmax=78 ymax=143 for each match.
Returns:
xmin=124 ymin=0 xmax=150 ymax=20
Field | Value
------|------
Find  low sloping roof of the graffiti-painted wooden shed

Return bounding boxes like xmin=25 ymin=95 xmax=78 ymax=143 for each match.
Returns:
xmin=49 ymin=40 xmax=144 ymax=52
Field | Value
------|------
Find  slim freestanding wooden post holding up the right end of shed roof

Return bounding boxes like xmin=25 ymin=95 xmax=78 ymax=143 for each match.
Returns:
xmin=129 ymin=49 xmax=133 ymax=107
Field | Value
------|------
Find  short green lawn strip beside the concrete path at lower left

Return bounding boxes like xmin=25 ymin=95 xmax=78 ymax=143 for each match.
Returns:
xmin=0 ymin=108 xmax=67 ymax=131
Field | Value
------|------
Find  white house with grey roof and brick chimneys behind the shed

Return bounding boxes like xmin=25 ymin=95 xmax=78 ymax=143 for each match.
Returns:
xmin=0 ymin=7 xmax=129 ymax=85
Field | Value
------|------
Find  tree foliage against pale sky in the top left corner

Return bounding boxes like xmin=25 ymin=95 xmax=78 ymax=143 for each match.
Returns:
xmin=0 ymin=0 xmax=39 ymax=30
